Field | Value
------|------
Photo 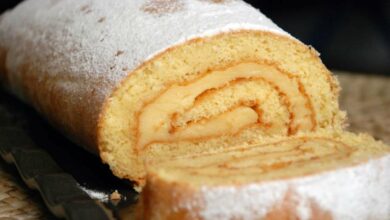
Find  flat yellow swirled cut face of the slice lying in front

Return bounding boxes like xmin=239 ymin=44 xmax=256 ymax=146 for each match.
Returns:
xmin=149 ymin=134 xmax=390 ymax=186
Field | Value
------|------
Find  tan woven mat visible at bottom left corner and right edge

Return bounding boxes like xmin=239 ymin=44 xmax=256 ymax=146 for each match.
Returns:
xmin=0 ymin=72 xmax=390 ymax=219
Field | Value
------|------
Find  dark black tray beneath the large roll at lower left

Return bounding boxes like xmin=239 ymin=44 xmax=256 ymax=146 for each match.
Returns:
xmin=0 ymin=90 xmax=138 ymax=219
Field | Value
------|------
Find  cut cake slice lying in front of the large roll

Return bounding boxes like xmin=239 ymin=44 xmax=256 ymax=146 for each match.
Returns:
xmin=139 ymin=133 xmax=390 ymax=220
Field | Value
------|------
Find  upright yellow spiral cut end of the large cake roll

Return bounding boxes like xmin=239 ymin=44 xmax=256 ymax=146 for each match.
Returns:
xmin=99 ymin=31 xmax=344 ymax=184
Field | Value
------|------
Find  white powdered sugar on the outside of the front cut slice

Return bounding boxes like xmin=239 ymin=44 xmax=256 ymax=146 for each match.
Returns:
xmin=176 ymin=155 xmax=390 ymax=220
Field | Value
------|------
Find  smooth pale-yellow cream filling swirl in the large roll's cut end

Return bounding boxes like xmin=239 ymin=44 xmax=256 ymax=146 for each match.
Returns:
xmin=137 ymin=62 xmax=315 ymax=149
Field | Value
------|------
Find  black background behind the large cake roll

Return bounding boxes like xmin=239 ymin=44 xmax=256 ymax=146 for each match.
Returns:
xmin=0 ymin=0 xmax=390 ymax=75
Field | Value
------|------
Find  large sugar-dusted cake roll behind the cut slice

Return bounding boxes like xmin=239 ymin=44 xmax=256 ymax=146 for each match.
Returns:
xmin=0 ymin=0 xmax=344 ymax=184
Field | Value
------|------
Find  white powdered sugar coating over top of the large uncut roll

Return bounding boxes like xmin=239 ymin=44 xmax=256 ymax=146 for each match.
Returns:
xmin=0 ymin=0 xmax=290 ymax=123
